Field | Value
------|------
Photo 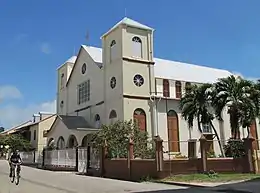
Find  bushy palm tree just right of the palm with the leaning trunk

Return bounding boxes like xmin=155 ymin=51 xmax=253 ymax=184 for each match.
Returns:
xmin=212 ymin=75 xmax=254 ymax=138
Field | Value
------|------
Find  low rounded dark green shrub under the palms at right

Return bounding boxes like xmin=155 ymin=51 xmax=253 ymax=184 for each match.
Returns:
xmin=224 ymin=139 xmax=245 ymax=158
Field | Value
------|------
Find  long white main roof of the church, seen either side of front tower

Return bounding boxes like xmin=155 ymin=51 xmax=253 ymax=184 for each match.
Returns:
xmin=80 ymin=46 xmax=232 ymax=83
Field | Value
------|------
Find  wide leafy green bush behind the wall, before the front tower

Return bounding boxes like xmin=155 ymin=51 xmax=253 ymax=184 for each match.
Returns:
xmin=93 ymin=120 xmax=155 ymax=158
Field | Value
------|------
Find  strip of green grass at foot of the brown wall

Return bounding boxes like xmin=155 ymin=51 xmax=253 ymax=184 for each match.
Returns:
xmin=162 ymin=173 xmax=260 ymax=182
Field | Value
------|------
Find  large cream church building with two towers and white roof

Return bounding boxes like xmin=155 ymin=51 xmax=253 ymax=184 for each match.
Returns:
xmin=46 ymin=18 xmax=258 ymax=155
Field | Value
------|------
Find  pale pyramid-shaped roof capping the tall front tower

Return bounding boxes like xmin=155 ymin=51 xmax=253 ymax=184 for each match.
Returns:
xmin=101 ymin=17 xmax=154 ymax=38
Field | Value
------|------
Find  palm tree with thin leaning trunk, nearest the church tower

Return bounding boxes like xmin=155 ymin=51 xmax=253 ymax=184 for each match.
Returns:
xmin=180 ymin=84 xmax=224 ymax=156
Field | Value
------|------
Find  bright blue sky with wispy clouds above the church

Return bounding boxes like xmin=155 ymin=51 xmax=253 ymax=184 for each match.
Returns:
xmin=0 ymin=0 xmax=260 ymax=127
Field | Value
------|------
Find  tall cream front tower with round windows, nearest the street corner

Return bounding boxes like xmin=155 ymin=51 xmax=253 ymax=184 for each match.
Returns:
xmin=102 ymin=18 xmax=155 ymax=132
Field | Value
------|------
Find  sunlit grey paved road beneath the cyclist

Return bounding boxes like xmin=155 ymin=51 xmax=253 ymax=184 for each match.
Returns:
xmin=0 ymin=160 xmax=231 ymax=193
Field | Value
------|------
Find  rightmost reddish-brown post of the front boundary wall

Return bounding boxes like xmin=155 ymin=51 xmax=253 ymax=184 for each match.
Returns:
xmin=243 ymin=133 xmax=256 ymax=173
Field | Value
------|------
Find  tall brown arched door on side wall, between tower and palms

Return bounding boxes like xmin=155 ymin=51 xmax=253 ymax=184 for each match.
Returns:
xmin=167 ymin=110 xmax=180 ymax=152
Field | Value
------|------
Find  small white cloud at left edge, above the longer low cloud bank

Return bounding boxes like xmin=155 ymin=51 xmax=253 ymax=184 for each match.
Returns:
xmin=0 ymin=85 xmax=22 ymax=100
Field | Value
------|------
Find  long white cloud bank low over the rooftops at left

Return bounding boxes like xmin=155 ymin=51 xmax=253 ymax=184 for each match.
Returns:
xmin=0 ymin=100 xmax=56 ymax=129
